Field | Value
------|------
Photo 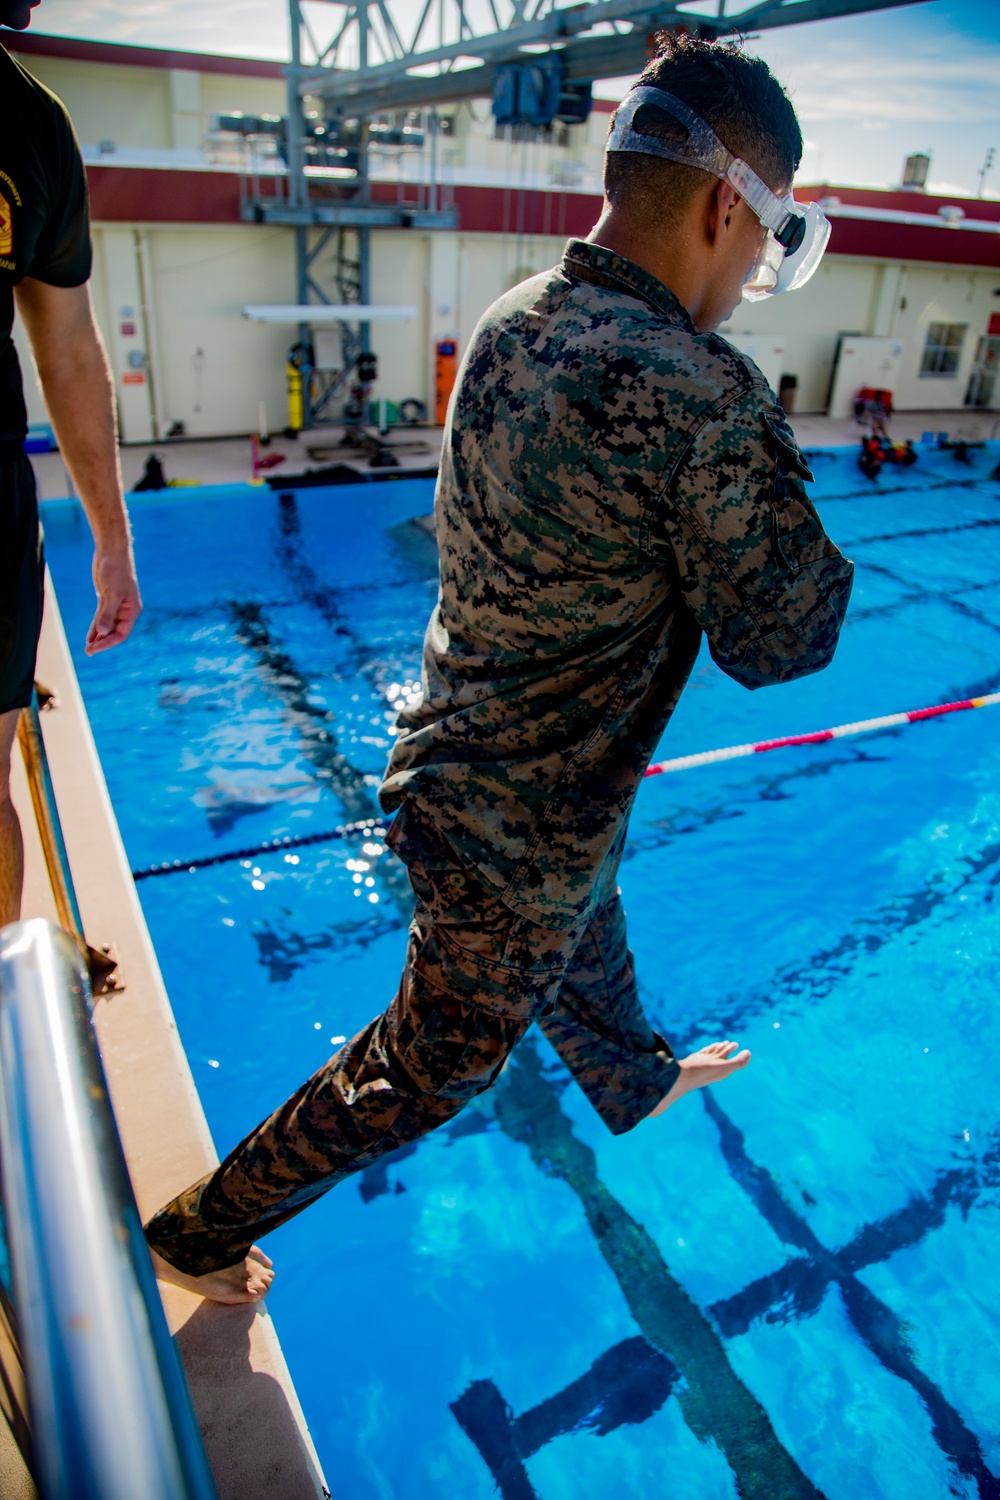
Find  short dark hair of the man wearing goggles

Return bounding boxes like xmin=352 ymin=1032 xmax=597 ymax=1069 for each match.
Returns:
xmin=604 ymin=32 xmax=802 ymax=222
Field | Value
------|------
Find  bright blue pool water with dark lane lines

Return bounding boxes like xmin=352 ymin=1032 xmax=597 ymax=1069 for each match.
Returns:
xmin=45 ymin=453 xmax=1000 ymax=1500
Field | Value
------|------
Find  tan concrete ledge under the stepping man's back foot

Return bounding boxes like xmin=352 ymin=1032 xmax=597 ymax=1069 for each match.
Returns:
xmin=10 ymin=579 xmax=328 ymax=1500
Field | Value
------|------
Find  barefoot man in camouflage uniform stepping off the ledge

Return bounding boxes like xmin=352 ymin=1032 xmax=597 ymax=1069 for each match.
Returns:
xmin=145 ymin=32 xmax=852 ymax=1301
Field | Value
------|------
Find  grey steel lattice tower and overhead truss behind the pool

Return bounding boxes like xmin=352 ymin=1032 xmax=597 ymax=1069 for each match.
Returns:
xmin=257 ymin=0 xmax=927 ymax=426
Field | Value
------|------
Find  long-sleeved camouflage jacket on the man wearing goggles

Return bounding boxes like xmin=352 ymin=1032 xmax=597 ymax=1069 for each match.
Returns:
xmin=379 ymin=240 xmax=853 ymax=927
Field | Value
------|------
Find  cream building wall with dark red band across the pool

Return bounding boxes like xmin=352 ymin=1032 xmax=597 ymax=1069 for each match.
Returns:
xmin=9 ymin=42 xmax=1000 ymax=443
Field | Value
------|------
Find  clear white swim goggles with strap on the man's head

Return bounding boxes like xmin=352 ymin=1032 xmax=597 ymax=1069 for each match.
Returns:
xmin=607 ymin=86 xmax=831 ymax=302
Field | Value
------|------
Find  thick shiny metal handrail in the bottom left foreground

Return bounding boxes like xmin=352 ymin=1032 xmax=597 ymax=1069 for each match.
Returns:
xmin=0 ymin=918 xmax=217 ymax=1500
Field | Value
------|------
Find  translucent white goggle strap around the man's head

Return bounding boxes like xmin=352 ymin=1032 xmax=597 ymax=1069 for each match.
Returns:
xmin=607 ymin=84 xmax=805 ymax=251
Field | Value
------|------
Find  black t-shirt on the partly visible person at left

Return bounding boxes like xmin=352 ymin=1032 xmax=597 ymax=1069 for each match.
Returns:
xmin=0 ymin=47 xmax=91 ymax=443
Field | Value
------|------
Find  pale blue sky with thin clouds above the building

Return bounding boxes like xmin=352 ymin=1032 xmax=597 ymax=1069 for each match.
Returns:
xmin=19 ymin=0 xmax=1000 ymax=198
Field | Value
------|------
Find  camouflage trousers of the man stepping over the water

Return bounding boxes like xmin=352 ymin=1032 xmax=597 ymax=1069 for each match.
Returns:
xmin=145 ymin=816 xmax=678 ymax=1275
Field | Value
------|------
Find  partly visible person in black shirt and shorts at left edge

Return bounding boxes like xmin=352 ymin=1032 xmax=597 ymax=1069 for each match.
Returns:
xmin=0 ymin=0 xmax=142 ymax=926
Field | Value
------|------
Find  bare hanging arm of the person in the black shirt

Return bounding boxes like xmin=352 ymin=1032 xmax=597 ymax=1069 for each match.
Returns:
xmin=15 ymin=276 xmax=142 ymax=656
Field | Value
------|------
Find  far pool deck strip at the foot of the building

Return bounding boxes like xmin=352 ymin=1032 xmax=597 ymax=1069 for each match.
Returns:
xmin=25 ymin=407 xmax=1000 ymax=500
